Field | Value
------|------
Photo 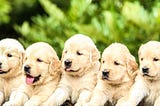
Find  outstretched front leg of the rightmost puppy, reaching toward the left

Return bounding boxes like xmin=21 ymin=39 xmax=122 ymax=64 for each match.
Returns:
xmin=116 ymin=77 xmax=149 ymax=106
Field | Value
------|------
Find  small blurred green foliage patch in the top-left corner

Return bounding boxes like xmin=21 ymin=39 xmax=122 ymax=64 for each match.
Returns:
xmin=0 ymin=0 xmax=11 ymax=25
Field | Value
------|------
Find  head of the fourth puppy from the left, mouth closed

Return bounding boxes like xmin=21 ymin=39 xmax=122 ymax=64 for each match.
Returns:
xmin=100 ymin=43 xmax=138 ymax=84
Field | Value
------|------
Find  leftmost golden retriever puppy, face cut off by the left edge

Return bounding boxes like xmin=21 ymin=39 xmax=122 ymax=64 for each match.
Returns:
xmin=0 ymin=38 xmax=24 ymax=105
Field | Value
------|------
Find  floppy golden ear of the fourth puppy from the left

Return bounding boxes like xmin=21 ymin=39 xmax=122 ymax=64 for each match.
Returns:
xmin=127 ymin=55 xmax=138 ymax=78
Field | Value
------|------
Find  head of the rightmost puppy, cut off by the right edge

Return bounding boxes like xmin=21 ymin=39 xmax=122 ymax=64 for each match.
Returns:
xmin=138 ymin=41 xmax=160 ymax=79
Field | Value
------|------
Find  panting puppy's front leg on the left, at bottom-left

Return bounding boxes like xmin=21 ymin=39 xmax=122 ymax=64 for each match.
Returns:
xmin=3 ymin=91 xmax=28 ymax=106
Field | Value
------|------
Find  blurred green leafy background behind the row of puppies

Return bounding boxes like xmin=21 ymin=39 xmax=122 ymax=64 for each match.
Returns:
xmin=0 ymin=0 xmax=160 ymax=58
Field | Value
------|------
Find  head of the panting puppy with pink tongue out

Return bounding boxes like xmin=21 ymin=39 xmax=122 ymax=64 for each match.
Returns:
xmin=23 ymin=42 xmax=60 ymax=85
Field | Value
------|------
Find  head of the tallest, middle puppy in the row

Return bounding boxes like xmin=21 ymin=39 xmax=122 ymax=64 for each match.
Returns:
xmin=62 ymin=34 xmax=100 ymax=76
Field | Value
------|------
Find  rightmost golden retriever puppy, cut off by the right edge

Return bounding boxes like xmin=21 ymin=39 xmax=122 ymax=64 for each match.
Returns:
xmin=117 ymin=41 xmax=160 ymax=106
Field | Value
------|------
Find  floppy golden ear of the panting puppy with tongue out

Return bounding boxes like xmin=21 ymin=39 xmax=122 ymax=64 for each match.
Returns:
xmin=49 ymin=58 xmax=61 ymax=76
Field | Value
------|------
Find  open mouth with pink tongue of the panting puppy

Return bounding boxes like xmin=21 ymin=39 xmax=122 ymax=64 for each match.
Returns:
xmin=26 ymin=73 xmax=41 ymax=85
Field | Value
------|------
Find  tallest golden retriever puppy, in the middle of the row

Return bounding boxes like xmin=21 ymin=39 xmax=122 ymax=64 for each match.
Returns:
xmin=43 ymin=34 xmax=100 ymax=106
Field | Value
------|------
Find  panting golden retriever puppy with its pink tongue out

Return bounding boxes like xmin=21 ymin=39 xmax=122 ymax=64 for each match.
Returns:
xmin=4 ymin=42 xmax=61 ymax=106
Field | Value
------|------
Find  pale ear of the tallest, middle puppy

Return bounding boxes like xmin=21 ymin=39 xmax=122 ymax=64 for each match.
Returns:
xmin=90 ymin=47 xmax=100 ymax=62
